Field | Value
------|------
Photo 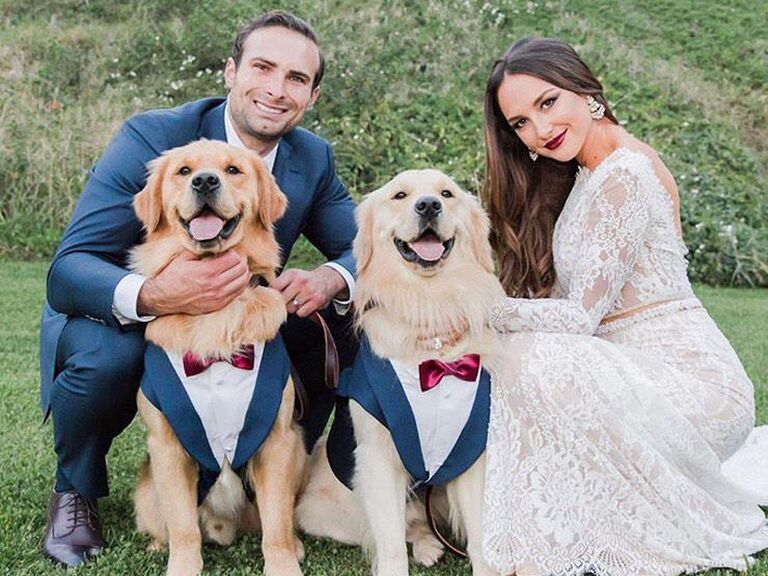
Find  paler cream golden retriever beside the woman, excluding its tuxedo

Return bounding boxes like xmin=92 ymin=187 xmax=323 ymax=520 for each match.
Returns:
xmin=297 ymin=170 xmax=504 ymax=576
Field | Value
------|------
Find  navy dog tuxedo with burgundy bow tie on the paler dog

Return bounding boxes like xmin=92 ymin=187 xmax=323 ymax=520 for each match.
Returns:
xmin=328 ymin=336 xmax=491 ymax=487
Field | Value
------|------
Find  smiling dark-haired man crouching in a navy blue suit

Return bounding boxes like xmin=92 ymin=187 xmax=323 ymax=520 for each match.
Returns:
xmin=40 ymin=11 xmax=355 ymax=566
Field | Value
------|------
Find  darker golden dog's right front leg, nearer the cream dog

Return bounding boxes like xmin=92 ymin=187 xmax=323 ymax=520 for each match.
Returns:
xmin=248 ymin=380 xmax=306 ymax=576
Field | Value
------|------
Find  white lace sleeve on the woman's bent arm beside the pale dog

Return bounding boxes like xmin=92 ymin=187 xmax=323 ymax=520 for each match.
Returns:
xmin=491 ymin=167 xmax=650 ymax=334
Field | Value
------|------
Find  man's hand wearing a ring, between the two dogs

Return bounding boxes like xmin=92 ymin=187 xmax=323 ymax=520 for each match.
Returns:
xmin=272 ymin=266 xmax=347 ymax=318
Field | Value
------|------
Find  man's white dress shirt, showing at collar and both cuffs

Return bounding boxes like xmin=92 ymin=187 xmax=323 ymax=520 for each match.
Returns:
xmin=112 ymin=100 xmax=355 ymax=325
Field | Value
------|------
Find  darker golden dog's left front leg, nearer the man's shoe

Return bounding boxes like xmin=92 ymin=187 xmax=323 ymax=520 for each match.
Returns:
xmin=137 ymin=392 xmax=203 ymax=576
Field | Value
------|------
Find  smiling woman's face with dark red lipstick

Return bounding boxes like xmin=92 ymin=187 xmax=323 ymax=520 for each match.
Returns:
xmin=497 ymin=74 xmax=593 ymax=162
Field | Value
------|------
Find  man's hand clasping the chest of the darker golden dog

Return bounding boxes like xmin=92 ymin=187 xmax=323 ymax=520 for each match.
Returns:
xmin=136 ymin=250 xmax=251 ymax=316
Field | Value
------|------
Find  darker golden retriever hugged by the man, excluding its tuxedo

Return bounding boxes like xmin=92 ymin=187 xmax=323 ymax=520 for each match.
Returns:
xmin=131 ymin=140 xmax=306 ymax=576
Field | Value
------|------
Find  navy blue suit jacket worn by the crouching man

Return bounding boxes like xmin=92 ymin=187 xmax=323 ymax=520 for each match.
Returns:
xmin=40 ymin=98 xmax=356 ymax=413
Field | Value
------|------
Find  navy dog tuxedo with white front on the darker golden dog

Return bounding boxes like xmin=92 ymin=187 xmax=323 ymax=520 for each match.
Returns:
xmin=141 ymin=334 xmax=291 ymax=504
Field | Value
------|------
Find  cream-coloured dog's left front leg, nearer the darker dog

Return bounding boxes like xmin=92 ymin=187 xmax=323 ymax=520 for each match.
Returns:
xmin=350 ymin=401 xmax=408 ymax=576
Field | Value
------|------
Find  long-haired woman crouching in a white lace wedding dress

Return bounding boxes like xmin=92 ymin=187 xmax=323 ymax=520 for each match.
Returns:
xmin=484 ymin=39 xmax=768 ymax=576
